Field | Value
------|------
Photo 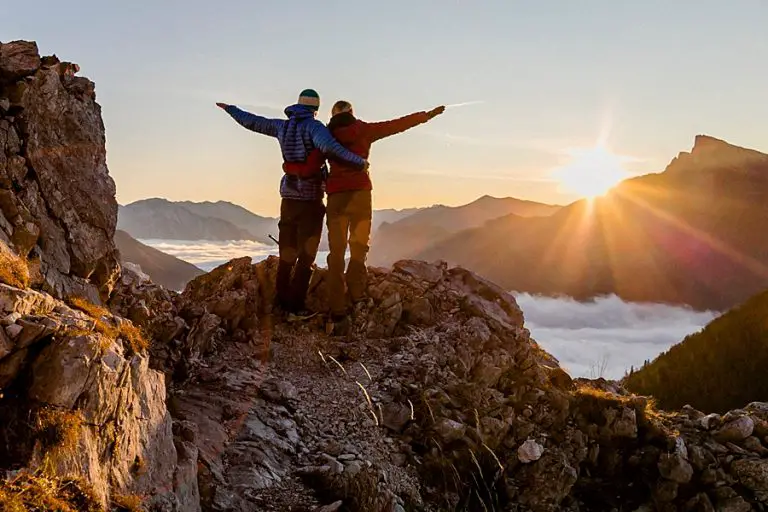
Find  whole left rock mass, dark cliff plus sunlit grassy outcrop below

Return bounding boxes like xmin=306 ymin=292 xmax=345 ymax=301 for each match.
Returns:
xmin=0 ymin=41 xmax=194 ymax=511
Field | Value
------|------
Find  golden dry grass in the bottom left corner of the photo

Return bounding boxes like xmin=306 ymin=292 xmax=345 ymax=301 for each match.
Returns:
xmin=0 ymin=471 xmax=104 ymax=512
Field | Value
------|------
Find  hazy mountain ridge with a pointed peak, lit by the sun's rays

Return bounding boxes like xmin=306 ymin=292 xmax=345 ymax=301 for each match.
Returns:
xmin=413 ymin=136 xmax=768 ymax=311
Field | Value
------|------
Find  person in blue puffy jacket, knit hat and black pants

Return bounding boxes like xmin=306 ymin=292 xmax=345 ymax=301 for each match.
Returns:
xmin=216 ymin=89 xmax=368 ymax=316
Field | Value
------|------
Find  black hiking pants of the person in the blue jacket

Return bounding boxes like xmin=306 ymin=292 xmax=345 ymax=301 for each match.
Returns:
xmin=277 ymin=199 xmax=325 ymax=312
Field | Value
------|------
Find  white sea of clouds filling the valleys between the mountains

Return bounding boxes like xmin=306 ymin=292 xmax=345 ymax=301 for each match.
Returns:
xmin=141 ymin=240 xmax=717 ymax=379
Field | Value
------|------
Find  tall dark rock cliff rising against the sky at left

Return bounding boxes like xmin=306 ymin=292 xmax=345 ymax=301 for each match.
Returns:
xmin=0 ymin=41 xmax=119 ymax=302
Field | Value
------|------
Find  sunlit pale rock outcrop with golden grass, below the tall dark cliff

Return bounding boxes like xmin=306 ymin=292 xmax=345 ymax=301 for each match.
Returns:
xmin=0 ymin=278 xmax=199 ymax=510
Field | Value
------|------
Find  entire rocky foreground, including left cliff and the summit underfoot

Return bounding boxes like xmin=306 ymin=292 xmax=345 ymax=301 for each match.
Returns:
xmin=0 ymin=43 xmax=768 ymax=512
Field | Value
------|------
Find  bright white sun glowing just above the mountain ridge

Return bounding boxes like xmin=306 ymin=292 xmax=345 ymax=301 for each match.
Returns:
xmin=552 ymin=145 xmax=633 ymax=199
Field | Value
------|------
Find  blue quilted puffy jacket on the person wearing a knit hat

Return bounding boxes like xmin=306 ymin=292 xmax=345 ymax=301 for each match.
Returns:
xmin=225 ymin=104 xmax=365 ymax=201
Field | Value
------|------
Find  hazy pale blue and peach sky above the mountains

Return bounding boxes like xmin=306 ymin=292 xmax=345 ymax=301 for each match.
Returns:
xmin=0 ymin=0 xmax=768 ymax=215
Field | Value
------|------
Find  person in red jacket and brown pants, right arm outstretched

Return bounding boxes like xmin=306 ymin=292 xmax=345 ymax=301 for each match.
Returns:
xmin=326 ymin=101 xmax=445 ymax=334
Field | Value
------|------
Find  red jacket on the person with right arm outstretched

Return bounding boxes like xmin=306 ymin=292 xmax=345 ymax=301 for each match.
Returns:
xmin=326 ymin=112 xmax=429 ymax=194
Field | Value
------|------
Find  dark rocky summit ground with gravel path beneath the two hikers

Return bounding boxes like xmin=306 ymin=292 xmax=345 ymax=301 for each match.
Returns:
xmin=109 ymin=258 xmax=768 ymax=511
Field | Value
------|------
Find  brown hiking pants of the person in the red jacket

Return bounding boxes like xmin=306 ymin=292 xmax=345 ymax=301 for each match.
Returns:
xmin=327 ymin=190 xmax=373 ymax=315
